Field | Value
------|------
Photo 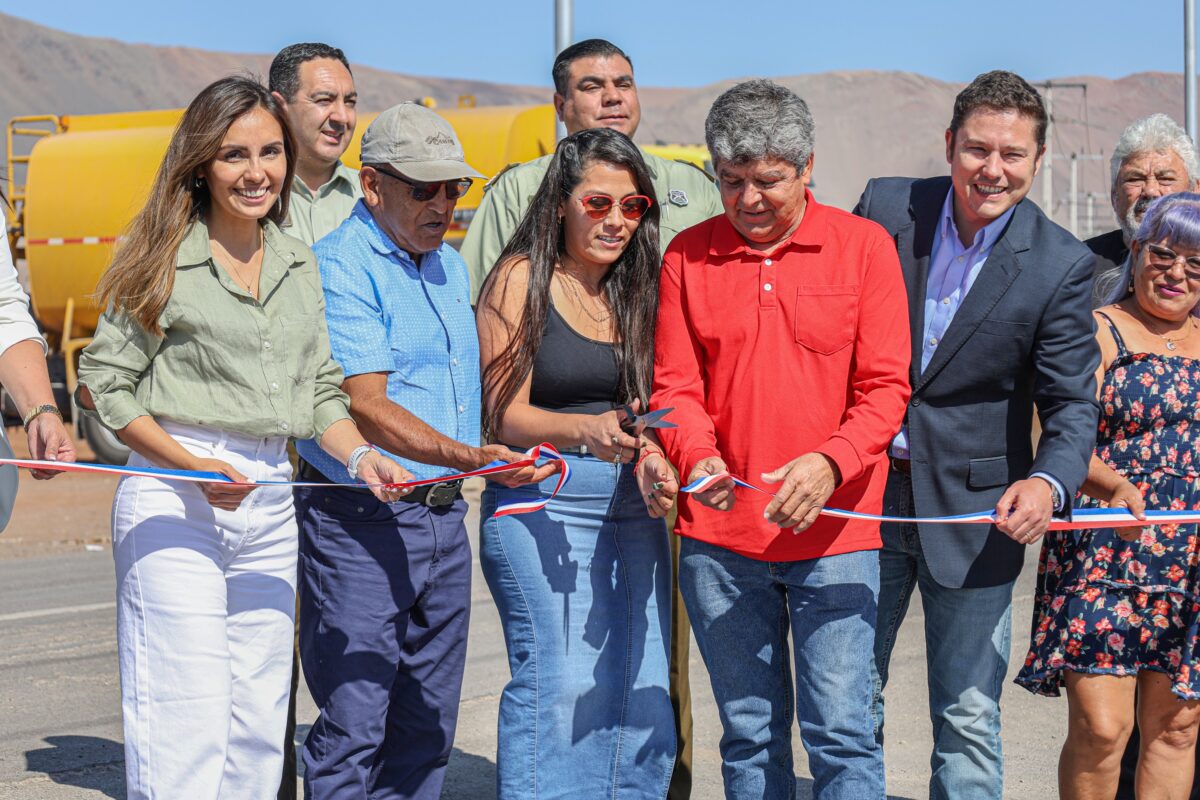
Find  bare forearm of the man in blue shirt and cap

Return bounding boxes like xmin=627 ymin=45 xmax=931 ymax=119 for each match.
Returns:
xmin=350 ymin=396 xmax=480 ymax=471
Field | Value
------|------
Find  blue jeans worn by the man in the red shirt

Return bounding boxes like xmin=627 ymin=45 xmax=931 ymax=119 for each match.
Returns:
xmin=679 ymin=534 xmax=884 ymax=800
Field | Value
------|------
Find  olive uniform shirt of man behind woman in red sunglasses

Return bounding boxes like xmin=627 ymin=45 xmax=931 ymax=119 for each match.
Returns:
xmin=461 ymin=150 xmax=724 ymax=303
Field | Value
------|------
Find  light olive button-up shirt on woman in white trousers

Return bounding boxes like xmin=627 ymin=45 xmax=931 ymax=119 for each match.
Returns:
xmin=79 ymin=219 xmax=350 ymax=439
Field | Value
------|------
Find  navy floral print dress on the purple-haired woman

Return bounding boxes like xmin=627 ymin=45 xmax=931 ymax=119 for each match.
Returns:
xmin=1016 ymin=313 xmax=1200 ymax=699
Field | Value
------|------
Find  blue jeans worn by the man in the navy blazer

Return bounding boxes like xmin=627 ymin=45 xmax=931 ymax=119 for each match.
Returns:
xmin=874 ymin=473 xmax=1013 ymax=800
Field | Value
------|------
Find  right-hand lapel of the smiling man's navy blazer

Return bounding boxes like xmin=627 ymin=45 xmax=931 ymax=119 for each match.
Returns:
xmin=913 ymin=208 xmax=1028 ymax=391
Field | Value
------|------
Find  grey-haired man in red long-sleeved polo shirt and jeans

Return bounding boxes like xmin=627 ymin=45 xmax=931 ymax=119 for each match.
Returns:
xmin=652 ymin=80 xmax=910 ymax=800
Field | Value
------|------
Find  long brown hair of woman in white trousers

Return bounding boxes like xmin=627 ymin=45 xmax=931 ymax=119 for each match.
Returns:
xmin=96 ymin=76 xmax=295 ymax=335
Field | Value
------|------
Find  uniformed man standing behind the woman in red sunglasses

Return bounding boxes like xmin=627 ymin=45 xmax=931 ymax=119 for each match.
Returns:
xmin=462 ymin=38 xmax=724 ymax=800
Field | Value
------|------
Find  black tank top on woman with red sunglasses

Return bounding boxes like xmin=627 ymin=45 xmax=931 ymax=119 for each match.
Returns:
xmin=529 ymin=305 xmax=620 ymax=414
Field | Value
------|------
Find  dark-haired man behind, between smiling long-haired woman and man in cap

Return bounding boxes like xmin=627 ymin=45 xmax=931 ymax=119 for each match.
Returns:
xmin=270 ymin=42 xmax=362 ymax=245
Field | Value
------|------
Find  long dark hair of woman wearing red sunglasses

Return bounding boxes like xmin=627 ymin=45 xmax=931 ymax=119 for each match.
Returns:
xmin=479 ymin=128 xmax=660 ymax=438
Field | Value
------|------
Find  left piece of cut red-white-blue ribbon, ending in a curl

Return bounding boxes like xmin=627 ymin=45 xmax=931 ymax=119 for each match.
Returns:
xmin=0 ymin=443 xmax=571 ymax=516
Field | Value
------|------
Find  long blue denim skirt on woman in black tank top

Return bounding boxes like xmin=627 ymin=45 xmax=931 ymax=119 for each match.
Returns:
xmin=479 ymin=455 xmax=676 ymax=800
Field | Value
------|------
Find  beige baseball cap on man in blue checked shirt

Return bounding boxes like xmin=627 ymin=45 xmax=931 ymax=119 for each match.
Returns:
xmin=361 ymin=103 xmax=484 ymax=184
